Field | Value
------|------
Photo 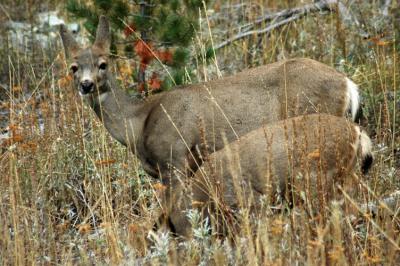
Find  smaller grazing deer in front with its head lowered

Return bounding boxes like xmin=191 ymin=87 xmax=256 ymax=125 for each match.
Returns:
xmin=170 ymin=114 xmax=373 ymax=236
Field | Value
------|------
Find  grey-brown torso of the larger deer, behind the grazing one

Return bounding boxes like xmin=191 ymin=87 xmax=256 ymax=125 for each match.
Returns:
xmin=142 ymin=59 xmax=354 ymax=177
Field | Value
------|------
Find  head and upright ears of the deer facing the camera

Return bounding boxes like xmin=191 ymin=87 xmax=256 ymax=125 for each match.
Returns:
xmin=60 ymin=16 xmax=110 ymax=96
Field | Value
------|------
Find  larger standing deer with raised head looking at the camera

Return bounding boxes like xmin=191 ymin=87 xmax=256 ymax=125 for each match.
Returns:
xmin=60 ymin=15 xmax=360 ymax=237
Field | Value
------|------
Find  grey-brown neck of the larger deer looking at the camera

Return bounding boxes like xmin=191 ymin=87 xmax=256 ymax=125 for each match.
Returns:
xmin=89 ymin=74 xmax=148 ymax=147
